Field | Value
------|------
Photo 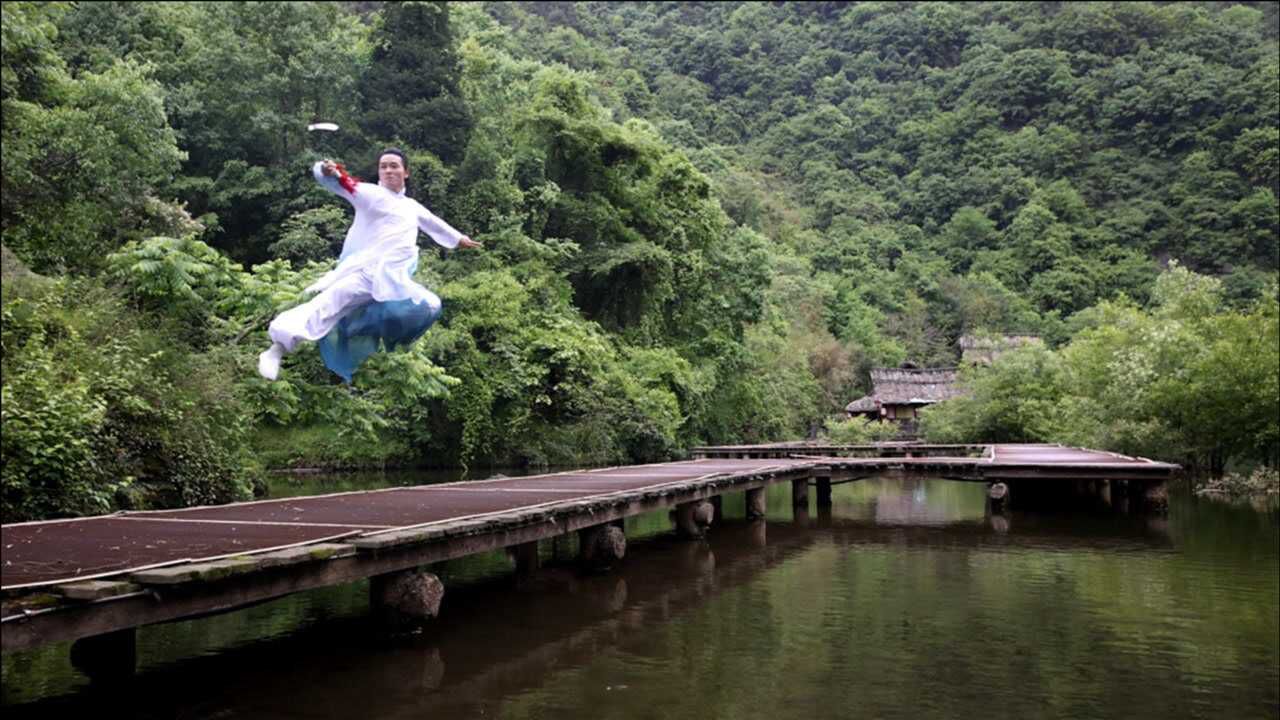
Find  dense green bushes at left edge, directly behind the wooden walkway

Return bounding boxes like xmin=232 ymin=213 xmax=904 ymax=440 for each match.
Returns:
xmin=0 ymin=270 xmax=252 ymax=521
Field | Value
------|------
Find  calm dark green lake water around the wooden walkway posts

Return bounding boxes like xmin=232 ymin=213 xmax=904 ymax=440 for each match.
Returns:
xmin=3 ymin=475 xmax=1280 ymax=720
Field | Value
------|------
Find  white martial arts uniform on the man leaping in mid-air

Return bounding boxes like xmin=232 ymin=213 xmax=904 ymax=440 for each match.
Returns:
xmin=268 ymin=163 xmax=465 ymax=352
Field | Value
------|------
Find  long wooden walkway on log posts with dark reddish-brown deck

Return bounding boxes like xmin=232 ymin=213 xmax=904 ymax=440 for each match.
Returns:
xmin=0 ymin=443 xmax=1178 ymax=671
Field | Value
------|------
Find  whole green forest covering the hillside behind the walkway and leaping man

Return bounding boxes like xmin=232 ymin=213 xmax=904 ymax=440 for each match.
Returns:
xmin=0 ymin=1 xmax=1280 ymax=523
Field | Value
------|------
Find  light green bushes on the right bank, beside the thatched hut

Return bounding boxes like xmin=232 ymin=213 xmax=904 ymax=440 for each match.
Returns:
xmin=922 ymin=266 xmax=1280 ymax=477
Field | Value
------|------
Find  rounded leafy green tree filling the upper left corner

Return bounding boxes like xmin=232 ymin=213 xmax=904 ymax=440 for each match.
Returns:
xmin=0 ymin=3 xmax=189 ymax=272
